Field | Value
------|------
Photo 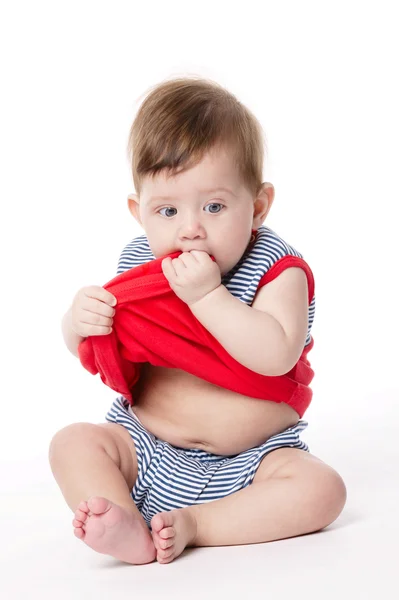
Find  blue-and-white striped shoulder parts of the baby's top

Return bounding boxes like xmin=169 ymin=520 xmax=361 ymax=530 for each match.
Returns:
xmin=117 ymin=225 xmax=315 ymax=346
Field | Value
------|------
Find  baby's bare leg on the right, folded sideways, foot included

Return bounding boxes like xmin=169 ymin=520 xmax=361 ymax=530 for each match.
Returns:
xmin=151 ymin=448 xmax=346 ymax=563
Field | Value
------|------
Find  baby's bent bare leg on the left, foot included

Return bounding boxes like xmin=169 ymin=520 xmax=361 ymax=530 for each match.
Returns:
xmin=49 ymin=423 xmax=156 ymax=564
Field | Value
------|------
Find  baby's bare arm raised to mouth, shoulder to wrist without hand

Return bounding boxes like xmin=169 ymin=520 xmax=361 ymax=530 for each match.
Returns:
xmin=190 ymin=267 xmax=308 ymax=376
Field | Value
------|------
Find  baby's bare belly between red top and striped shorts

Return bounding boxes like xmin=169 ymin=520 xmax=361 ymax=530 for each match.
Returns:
xmin=132 ymin=363 xmax=299 ymax=456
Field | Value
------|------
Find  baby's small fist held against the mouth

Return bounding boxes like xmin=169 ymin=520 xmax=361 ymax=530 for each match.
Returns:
xmin=161 ymin=250 xmax=222 ymax=306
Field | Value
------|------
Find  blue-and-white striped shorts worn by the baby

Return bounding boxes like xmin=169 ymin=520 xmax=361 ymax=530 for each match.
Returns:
xmin=105 ymin=396 xmax=309 ymax=529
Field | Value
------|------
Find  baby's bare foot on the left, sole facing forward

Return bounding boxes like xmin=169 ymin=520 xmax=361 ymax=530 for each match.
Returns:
xmin=72 ymin=496 xmax=156 ymax=565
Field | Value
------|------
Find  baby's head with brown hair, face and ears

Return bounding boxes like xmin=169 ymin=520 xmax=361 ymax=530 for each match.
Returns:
xmin=128 ymin=78 xmax=274 ymax=275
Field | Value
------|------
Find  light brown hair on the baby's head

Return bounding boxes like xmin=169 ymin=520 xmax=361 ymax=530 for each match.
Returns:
xmin=128 ymin=77 xmax=265 ymax=197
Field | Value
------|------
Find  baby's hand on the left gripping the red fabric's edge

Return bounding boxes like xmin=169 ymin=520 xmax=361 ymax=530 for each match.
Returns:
xmin=71 ymin=285 xmax=116 ymax=337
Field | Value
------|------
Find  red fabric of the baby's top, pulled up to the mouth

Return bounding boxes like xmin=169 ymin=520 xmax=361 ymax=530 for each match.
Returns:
xmin=78 ymin=251 xmax=314 ymax=417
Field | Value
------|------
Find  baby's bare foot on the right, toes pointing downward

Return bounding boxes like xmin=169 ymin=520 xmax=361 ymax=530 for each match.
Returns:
xmin=151 ymin=508 xmax=197 ymax=564
